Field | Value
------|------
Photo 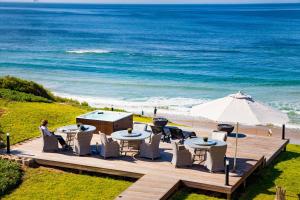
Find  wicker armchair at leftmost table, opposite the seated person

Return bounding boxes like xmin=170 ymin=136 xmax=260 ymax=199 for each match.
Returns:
xmin=74 ymin=132 xmax=93 ymax=156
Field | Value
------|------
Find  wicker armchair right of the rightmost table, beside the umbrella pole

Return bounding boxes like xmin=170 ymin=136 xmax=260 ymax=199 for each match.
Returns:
xmin=204 ymin=145 xmax=227 ymax=172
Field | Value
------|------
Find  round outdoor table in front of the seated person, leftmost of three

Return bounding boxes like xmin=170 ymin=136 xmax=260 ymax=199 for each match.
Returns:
xmin=56 ymin=124 xmax=96 ymax=147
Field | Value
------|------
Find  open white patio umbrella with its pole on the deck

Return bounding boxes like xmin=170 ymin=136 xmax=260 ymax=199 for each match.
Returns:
xmin=191 ymin=92 xmax=289 ymax=170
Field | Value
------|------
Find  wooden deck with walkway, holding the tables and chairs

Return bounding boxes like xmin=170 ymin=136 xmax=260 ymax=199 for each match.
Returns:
xmin=4 ymin=132 xmax=288 ymax=200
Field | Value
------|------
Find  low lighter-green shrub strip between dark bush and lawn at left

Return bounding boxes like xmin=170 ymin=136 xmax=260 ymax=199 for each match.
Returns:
xmin=0 ymin=89 xmax=52 ymax=103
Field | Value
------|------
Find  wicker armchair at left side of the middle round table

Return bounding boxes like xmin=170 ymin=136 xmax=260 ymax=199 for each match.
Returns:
xmin=99 ymin=132 xmax=120 ymax=159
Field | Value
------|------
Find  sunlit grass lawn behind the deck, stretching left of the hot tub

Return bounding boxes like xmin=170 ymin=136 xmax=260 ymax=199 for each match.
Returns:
xmin=0 ymin=98 xmax=159 ymax=144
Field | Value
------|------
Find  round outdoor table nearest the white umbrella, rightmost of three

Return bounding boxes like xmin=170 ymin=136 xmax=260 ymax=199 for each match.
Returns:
xmin=184 ymin=137 xmax=227 ymax=164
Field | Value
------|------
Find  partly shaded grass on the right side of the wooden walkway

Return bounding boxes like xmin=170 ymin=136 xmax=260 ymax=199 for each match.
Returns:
xmin=171 ymin=144 xmax=300 ymax=200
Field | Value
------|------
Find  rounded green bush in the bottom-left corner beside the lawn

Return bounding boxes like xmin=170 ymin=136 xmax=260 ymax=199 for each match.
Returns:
xmin=0 ymin=159 xmax=22 ymax=196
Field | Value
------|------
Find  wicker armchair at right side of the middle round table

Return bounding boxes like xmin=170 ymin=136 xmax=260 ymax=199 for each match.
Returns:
xmin=140 ymin=133 xmax=162 ymax=160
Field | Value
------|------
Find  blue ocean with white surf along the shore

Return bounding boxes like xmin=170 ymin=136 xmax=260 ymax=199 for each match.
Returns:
xmin=0 ymin=3 xmax=300 ymax=125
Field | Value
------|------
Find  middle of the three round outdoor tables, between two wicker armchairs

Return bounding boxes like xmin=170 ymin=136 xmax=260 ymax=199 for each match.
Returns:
xmin=111 ymin=130 xmax=151 ymax=153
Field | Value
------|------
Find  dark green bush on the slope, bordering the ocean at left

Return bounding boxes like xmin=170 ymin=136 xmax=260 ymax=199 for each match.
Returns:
xmin=0 ymin=76 xmax=55 ymax=101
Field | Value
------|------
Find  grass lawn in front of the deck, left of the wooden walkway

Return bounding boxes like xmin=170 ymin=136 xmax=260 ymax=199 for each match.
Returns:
xmin=2 ymin=167 xmax=132 ymax=200
